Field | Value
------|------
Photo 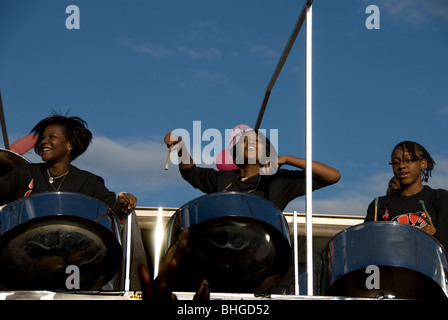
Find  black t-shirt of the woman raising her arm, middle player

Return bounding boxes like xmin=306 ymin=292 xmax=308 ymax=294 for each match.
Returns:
xmin=180 ymin=166 xmax=329 ymax=211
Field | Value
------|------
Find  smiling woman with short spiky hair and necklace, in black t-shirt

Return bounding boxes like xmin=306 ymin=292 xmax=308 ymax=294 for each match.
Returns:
xmin=0 ymin=114 xmax=146 ymax=289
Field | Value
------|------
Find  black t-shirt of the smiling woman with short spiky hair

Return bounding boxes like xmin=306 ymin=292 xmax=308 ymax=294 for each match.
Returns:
xmin=0 ymin=163 xmax=115 ymax=207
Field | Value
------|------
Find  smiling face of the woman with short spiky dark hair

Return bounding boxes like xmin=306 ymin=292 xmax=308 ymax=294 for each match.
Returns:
xmin=39 ymin=124 xmax=72 ymax=163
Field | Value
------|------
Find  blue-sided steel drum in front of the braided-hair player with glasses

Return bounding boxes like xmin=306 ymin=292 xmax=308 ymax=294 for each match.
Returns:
xmin=321 ymin=222 xmax=448 ymax=299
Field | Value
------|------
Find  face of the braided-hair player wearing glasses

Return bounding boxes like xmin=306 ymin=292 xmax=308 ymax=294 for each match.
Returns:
xmin=391 ymin=148 xmax=428 ymax=189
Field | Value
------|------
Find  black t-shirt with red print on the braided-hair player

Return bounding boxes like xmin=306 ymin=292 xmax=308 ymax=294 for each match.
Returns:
xmin=364 ymin=186 xmax=448 ymax=250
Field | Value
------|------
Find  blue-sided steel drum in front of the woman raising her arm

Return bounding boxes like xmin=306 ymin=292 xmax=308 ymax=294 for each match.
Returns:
xmin=165 ymin=192 xmax=291 ymax=293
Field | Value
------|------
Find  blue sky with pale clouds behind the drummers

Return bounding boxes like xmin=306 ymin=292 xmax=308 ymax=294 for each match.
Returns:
xmin=0 ymin=0 xmax=448 ymax=215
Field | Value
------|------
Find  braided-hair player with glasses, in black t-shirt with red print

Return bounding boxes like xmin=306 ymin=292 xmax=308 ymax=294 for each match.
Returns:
xmin=365 ymin=141 xmax=448 ymax=249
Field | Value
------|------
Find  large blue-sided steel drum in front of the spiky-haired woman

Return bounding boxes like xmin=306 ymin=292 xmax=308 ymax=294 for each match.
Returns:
xmin=0 ymin=192 xmax=122 ymax=290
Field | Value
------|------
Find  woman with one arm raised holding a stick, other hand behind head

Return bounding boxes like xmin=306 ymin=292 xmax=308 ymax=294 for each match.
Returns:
xmin=164 ymin=127 xmax=341 ymax=211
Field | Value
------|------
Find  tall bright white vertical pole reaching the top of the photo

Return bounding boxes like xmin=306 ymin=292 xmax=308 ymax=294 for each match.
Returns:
xmin=305 ymin=1 xmax=313 ymax=296
